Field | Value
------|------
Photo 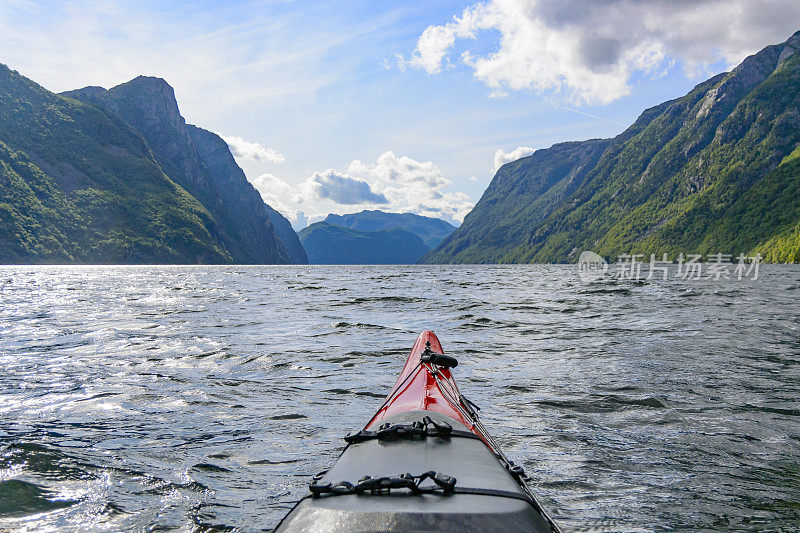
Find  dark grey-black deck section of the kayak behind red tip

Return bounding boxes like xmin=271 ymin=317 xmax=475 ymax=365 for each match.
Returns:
xmin=276 ymin=410 xmax=554 ymax=533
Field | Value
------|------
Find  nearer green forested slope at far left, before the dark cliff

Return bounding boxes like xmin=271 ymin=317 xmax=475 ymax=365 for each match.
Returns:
xmin=0 ymin=65 xmax=231 ymax=263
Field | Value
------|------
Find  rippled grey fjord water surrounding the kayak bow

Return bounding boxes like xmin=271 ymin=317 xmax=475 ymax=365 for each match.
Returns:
xmin=0 ymin=265 xmax=800 ymax=531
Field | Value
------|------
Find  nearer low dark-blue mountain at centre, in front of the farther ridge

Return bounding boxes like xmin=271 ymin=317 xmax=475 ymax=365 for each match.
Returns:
xmin=299 ymin=221 xmax=428 ymax=265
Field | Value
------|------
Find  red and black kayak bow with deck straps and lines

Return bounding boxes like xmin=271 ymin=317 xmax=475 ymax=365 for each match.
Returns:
xmin=275 ymin=331 xmax=560 ymax=533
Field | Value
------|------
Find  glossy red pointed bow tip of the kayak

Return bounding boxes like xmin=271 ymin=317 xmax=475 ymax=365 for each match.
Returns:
xmin=364 ymin=331 xmax=484 ymax=447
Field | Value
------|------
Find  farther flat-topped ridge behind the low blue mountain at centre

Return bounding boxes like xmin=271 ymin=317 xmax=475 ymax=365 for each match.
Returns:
xmin=325 ymin=210 xmax=456 ymax=248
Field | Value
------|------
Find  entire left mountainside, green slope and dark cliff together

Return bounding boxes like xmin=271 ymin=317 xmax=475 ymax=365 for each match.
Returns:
xmin=0 ymin=65 xmax=305 ymax=263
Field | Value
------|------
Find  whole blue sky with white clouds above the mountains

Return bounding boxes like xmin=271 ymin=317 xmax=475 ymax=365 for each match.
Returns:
xmin=0 ymin=0 xmax=800 ymax=229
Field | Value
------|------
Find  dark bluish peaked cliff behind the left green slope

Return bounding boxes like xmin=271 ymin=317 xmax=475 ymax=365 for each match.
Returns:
xmin=63 ymin=76 xmax=290 ymax=264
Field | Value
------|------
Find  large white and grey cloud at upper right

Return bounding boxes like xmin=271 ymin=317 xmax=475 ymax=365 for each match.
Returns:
xmin=405 ymin=0 xmax=800 ymax=104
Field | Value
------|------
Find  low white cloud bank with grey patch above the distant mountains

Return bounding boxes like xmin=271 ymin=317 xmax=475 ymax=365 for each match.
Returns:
xmin=248 ymin=152 xmax=475 ymax=229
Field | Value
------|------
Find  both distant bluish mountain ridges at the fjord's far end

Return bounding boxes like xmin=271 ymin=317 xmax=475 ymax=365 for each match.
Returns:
xmin=299 ymin=211 xmax=455 ymax=264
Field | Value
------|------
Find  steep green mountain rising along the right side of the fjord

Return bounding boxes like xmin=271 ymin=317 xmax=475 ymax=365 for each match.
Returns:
xmin=422 ymin=32 xmax=800 ymax=263
